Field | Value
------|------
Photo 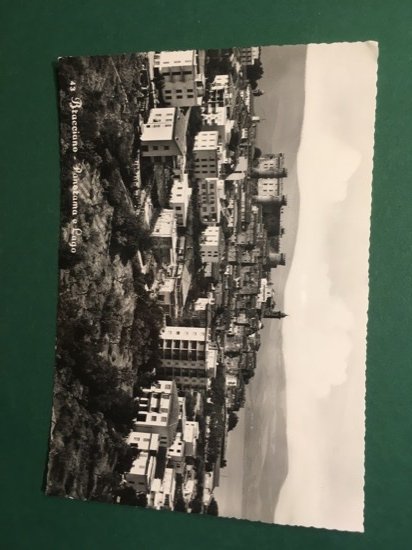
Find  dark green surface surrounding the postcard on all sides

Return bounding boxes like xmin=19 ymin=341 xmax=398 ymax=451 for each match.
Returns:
xmin=0 ymin=0 xmax=412 ymax=549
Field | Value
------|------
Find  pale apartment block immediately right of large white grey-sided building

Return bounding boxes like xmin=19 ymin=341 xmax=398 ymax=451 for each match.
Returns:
xmin=193 ymin=130 xmax=219 ymax=179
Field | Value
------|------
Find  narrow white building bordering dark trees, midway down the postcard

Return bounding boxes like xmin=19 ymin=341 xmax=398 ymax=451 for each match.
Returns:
xmin=151 ymin=208 xmax=177 ymax=265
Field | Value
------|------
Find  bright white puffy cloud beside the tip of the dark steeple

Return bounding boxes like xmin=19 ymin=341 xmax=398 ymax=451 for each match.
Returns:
xmin=284 ymin=256 xmax=354 ymax=398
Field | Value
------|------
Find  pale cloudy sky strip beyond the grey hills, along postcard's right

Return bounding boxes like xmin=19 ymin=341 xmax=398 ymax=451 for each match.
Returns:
xmin=275 ymin=43 xmax=377 ymax=531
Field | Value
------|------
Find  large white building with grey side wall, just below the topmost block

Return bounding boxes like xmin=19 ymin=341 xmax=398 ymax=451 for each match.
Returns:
xmin=141 ymin=107 xmax=188 ymax=162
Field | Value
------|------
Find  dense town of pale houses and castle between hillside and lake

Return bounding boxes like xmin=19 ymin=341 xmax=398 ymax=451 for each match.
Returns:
xmin=126 ymin=48 xmax=287 ymax=510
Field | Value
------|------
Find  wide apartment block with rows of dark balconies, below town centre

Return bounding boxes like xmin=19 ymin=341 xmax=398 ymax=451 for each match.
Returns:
xmin=158 ymin=326 xmax=217 ymax=389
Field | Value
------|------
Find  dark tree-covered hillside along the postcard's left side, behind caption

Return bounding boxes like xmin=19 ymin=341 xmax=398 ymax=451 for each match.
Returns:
xmin=46 ymin=55 xmax=161 ymax=499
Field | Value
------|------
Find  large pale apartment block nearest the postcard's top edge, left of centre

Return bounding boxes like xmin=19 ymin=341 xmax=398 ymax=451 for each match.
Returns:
xmin=154 ymin=50 xmax=205 ymax=107
